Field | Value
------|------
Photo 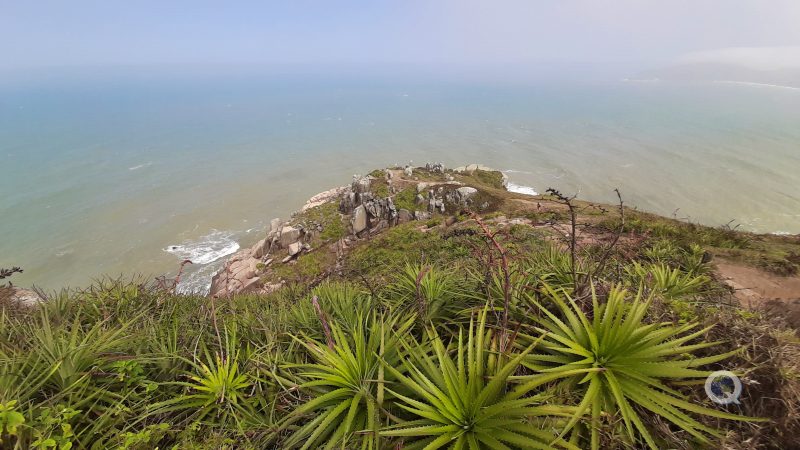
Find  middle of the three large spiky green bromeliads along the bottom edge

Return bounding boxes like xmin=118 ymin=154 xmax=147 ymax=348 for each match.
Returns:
xmin=381 ymin=311 xmax=586 ymax=450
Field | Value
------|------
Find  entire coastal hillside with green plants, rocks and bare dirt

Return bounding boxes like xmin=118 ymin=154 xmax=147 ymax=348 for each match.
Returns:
xmin=0 ymin=164 xmax=800 ymax=449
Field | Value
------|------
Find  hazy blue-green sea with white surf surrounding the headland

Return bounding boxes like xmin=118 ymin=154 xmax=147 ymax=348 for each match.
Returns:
xmin=0 ymin=75 xmax=800 ymax=290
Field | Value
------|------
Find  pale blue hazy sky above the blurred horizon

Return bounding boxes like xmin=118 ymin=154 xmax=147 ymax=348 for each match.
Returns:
xmin=0 ymin=0 xmax=800 ymax=69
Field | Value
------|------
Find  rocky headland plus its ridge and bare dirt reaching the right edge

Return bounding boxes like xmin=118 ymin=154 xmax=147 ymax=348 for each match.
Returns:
xmin=209 ymin=163 xmax=800 ymax=327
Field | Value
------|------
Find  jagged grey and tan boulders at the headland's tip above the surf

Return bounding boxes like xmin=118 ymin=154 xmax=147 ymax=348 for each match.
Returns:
xmin=209 ymin=163 xmax=508 ymax=297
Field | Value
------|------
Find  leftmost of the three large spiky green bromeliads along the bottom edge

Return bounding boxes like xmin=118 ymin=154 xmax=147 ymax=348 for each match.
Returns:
xmin=281 ymin=313 xmax=413 ymax=449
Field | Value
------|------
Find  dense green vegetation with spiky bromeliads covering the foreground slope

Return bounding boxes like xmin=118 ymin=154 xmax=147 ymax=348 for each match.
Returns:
xmin=0 ymin=211 xmax=796 ymax=449
